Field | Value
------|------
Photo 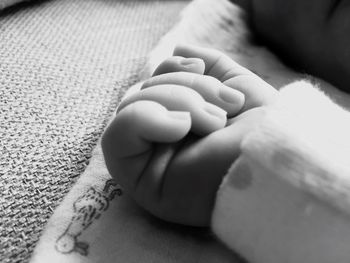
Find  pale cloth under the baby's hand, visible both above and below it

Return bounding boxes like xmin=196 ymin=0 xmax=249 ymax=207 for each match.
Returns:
xmin=27 ymin=0 xmax=350 ymax=263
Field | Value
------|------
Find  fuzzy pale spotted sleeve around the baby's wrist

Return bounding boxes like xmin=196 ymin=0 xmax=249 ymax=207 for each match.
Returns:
xmin=212 ymin=82 xmax=350 ymax=263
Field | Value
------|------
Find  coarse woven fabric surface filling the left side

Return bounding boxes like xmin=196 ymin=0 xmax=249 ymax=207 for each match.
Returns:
xmin=0 ymin=0 xmax=186 ymax=263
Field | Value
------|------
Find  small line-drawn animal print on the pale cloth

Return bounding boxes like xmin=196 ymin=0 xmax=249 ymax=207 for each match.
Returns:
xmin=55 ymin=179 xmax=122 ymax=256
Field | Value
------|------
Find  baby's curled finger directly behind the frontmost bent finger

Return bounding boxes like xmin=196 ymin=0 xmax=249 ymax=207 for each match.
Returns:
xmin=118 ymin=84 xmax=227 ymax=136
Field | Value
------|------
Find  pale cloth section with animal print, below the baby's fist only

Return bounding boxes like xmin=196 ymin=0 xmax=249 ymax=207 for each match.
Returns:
xmin=31 ymin=138 xmax=242 ymax=263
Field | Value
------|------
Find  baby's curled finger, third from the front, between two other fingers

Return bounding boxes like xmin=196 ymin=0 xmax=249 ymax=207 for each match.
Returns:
xmin=141 ymin=72 xmax=245 ymax=117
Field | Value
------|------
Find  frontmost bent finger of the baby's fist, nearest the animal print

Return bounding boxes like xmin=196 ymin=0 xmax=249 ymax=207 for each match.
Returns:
xmin=102 ymin=101 xmax=191 ymax=191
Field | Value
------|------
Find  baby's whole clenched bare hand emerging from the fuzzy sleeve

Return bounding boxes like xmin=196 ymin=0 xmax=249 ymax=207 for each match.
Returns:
xmin=102 ymin=46 xmax=277 ymax=226
